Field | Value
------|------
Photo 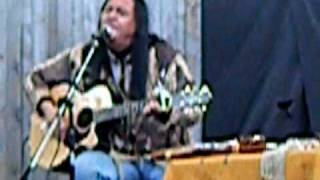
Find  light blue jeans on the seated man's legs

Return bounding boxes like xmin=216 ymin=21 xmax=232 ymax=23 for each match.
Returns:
xmin=73 ymin=151 xmax=164 ymax=180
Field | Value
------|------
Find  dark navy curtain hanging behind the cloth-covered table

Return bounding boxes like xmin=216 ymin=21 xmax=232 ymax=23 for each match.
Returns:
xmin=202 ymin=0 xmax=320 ymax=141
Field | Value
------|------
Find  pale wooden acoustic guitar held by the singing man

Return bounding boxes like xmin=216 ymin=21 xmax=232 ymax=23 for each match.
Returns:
xmin=29 ymin=85 xmax=212 ymax=169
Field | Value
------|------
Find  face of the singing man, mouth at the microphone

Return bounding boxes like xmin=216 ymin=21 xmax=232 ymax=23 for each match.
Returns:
xmin=101 ymin=0 xmax=136 ymax=51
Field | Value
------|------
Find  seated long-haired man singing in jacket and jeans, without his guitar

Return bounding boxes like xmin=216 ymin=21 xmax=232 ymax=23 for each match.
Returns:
xmin=26 ymin=0 xmax=201 ymax=180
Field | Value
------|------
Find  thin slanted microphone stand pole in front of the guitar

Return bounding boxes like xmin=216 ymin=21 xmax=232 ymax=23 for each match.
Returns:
xmin=20 ymin=37 xmax=99 ymax=180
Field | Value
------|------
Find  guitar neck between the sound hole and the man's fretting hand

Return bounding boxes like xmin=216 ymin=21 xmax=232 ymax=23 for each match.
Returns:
xmin=94 ymin=101 xmax=145 ymax=123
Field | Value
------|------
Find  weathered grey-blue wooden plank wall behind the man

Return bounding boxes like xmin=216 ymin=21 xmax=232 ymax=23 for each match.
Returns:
xmin=0 ymin=0 xmax=201 ymax=180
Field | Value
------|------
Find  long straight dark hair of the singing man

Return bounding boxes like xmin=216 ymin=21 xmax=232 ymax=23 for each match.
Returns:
xmin=98 ymin=0 xmax=149 ymax=99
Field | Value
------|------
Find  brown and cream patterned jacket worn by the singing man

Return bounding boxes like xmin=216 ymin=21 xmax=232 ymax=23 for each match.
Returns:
xmin=26 ymin=36 xmax=201 ymax=153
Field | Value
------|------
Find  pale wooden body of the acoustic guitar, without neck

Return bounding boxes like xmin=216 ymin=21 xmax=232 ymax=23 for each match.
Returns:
xmin=29 ymin=85 xmax=112 ymax=169
